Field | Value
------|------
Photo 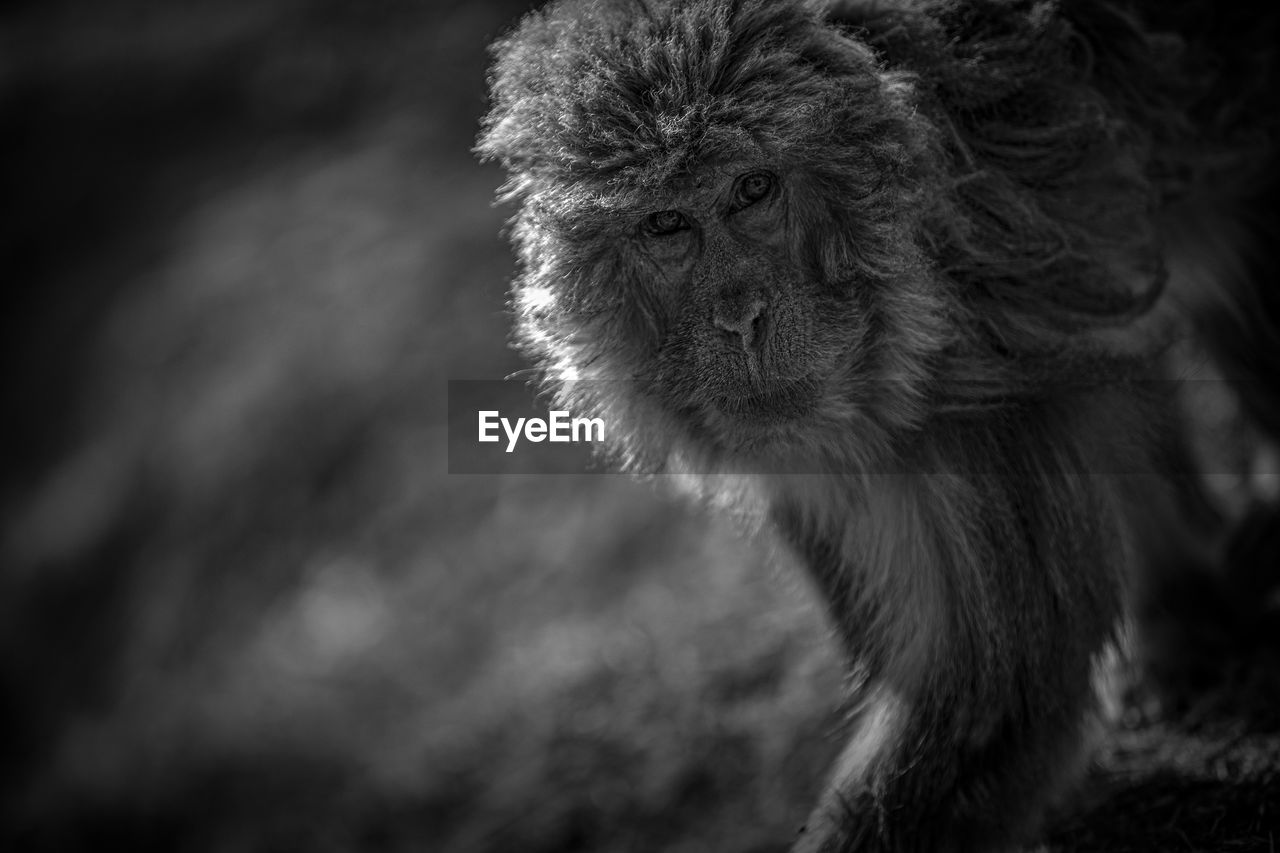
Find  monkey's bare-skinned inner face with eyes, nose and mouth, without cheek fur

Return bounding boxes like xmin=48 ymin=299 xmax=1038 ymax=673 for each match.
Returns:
xmin=634 ymin=163 xmax=870 ymax=438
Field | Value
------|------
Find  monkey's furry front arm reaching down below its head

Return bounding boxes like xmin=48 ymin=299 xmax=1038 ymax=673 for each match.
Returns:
xmin=774 ymin=401 xmax=1126 ymax=853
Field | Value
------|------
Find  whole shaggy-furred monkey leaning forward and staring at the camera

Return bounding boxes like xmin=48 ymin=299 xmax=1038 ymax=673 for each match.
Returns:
xmin=476 ymin=0 xmax=1280 ymax=853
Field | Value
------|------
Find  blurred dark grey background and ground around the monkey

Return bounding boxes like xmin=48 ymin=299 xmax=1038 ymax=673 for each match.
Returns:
xmin=0 ymin=0 xmax=1280 ymax=853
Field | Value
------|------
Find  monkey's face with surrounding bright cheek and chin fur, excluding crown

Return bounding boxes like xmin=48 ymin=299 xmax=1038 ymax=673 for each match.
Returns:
xmin=504 ymin=151 xmax=938 ymax=471
